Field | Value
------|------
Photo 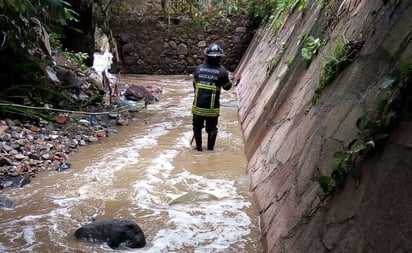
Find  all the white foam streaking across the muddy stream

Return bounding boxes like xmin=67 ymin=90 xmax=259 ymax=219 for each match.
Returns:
xmin=0 ymin=72 xmax=260 ymax=253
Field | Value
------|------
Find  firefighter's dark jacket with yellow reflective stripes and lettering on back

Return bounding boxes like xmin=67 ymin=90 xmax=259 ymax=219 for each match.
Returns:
xmin=192 ymin=63 xmax=232 ymax=117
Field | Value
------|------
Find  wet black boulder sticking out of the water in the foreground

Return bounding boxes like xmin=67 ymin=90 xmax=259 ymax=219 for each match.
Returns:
xmin=74 ymin=219 xmax=146 ymax=249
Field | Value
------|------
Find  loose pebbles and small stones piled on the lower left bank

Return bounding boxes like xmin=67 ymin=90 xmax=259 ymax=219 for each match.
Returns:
xmin=0 ymin=115 xmax=117 ymax=189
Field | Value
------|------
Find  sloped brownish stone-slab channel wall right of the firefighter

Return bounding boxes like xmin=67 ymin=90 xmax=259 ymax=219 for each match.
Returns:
xmin=235 ymin=0 xmax=412 ymax=253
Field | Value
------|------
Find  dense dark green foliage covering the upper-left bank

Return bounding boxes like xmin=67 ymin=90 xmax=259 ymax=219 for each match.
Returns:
xmin=0 ymin=0 xmax=99 ymax=118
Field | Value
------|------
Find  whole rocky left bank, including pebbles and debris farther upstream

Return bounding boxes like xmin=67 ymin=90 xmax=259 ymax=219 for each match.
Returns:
xmin=0 ymin=54 xmax=151 ymax=191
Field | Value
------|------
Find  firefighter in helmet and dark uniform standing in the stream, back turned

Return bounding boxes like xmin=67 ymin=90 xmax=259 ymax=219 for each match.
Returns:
xmin=192 ymin=43 xmax=232 ymax=151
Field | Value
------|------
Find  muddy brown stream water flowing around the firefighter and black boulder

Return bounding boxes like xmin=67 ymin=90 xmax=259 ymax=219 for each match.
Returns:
xmin=0 ymin=70 xmax=262 ymax=253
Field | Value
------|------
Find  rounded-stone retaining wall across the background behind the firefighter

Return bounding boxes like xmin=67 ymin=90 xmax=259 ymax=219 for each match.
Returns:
xmin=110 ymin=15 xmax=253 ymax=74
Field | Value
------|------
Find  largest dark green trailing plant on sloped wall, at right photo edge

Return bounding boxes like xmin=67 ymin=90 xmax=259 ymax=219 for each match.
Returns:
xmin=318 ymin=62 xmax=412 ymax=195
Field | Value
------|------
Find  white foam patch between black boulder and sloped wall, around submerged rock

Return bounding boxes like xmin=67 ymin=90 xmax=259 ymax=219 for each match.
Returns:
xmin=133 ymin=146 xmax=251 ymax=253
